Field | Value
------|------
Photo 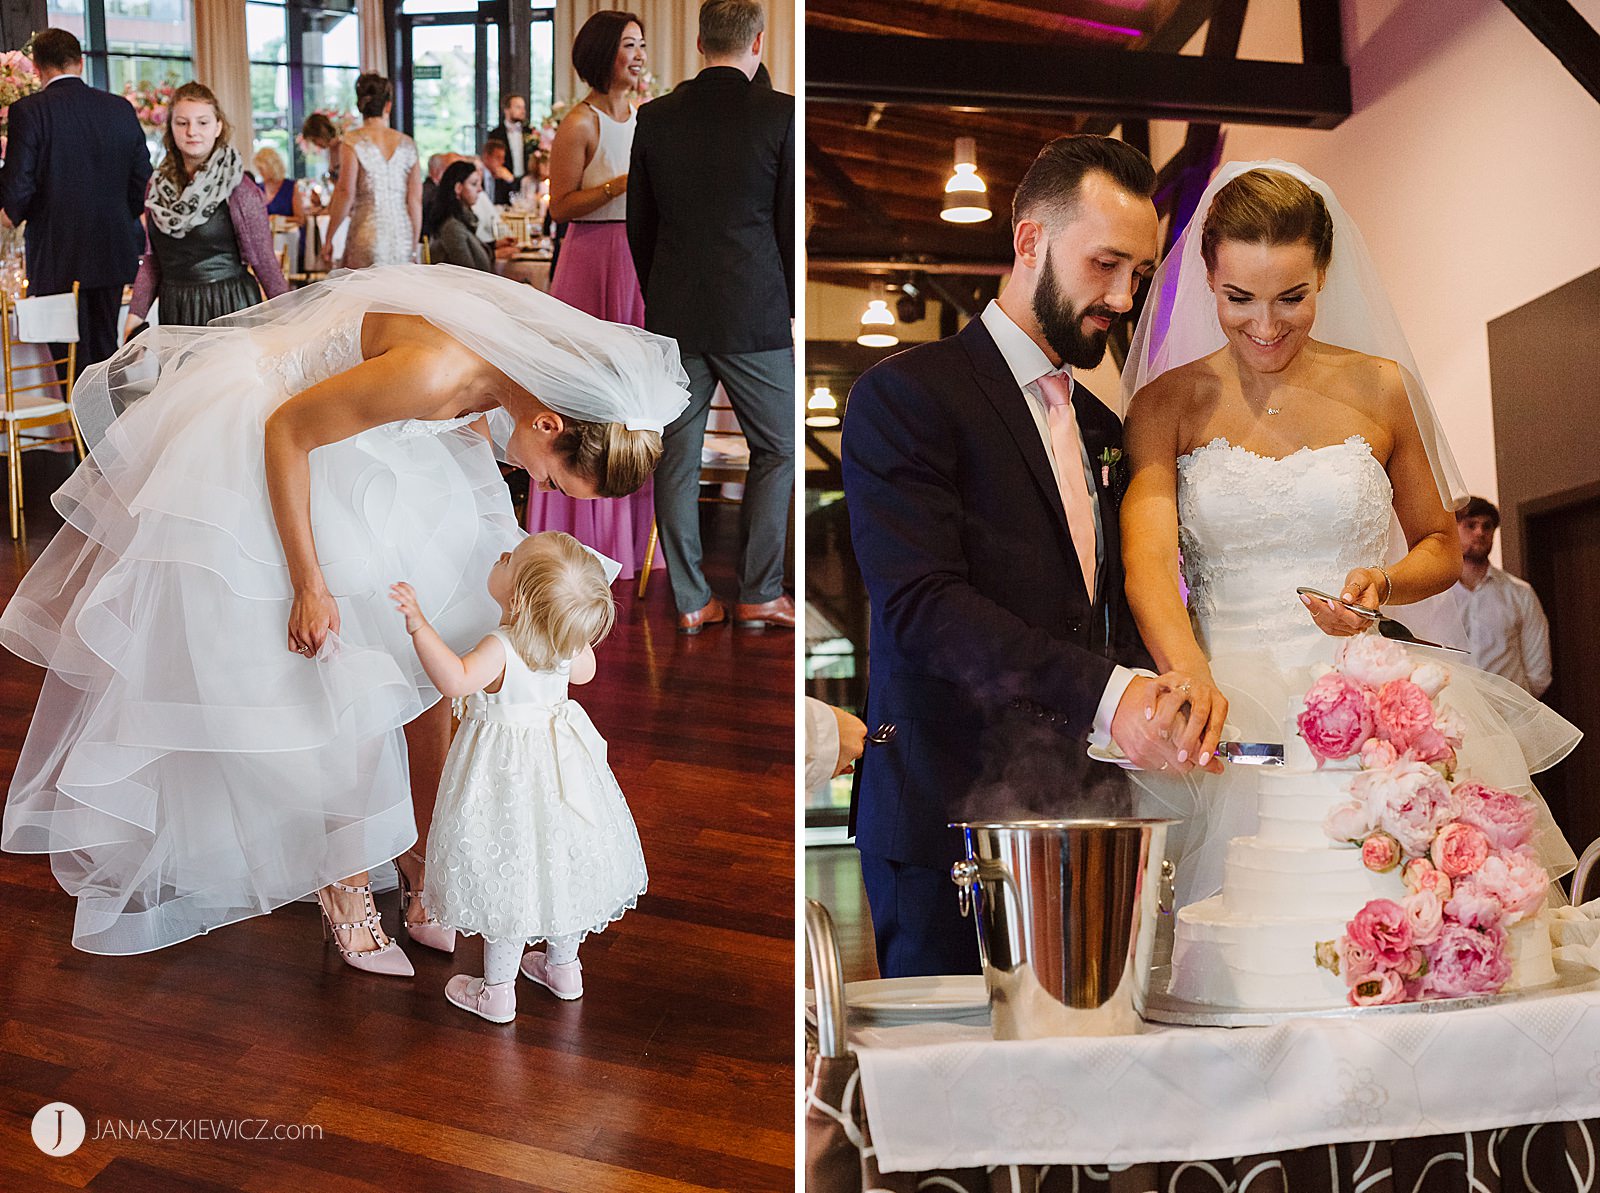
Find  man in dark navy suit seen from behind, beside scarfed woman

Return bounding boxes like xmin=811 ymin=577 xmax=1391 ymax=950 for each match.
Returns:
xmin=0 ymin=29 xmax=150 ymax=369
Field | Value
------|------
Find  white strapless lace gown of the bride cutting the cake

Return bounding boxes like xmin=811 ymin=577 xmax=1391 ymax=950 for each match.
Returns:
xmin=1134 ymin=435 xmax=1579 ymax=904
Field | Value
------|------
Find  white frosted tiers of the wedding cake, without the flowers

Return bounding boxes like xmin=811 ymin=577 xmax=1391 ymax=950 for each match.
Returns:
xmin=1170 ymin=707 xmax=1555 ymax=1009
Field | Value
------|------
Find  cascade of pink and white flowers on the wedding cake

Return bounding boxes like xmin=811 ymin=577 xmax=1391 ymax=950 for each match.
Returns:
xmin=1298 ymin=633 xmax=1550 ymax=1006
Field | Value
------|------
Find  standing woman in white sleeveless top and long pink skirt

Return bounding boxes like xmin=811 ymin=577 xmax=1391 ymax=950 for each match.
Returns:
xmin=528 ymin=11 xmax=654 ymax=579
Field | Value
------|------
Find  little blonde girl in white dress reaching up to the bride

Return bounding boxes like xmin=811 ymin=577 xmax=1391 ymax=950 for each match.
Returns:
xmin=390 ymin=531 xmax=645 ymax=1023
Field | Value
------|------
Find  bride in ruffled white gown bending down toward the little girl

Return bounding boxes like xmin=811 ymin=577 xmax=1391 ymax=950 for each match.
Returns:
xmin=0 ymin=265 xmax=686 ymax=972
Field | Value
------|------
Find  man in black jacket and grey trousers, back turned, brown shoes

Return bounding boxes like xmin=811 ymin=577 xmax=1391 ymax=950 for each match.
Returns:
xmin=627 ymin=0 xmax=795 ymax=633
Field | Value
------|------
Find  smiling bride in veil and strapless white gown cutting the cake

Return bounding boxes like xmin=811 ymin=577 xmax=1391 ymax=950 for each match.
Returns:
xmin=1122 ymin=162 xmax=1578 ymax=904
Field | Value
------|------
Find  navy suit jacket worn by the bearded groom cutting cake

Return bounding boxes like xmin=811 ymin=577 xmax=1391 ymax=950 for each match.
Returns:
xmin=843 ymin=318 xmax=1149 ymax=867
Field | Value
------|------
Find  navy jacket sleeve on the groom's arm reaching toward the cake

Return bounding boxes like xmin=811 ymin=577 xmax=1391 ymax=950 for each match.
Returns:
xmin=843 ymin=365 xmax=1114 ymax=734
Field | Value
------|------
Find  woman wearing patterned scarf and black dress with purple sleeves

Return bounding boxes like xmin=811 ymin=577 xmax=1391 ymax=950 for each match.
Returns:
xmin=126 ymin=83 xmax=288 ymax=334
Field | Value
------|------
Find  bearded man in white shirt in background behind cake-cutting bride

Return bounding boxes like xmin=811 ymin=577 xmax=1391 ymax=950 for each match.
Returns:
xmin=1450 ymin=497 xmax=1550 ymax=696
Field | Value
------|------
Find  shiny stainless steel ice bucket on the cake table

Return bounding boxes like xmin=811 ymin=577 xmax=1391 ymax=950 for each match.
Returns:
xmin=950 ymin=819 xmax=1174 ymax=1039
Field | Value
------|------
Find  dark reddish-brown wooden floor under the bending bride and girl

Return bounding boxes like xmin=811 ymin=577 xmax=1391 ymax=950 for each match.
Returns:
xmin=0 ymin=457 xmax=795 ymax=1193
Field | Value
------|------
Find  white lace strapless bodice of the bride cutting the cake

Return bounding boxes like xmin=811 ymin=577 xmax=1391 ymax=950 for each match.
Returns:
xmin=1178 ymin=435 xmax=1394 ymax=667
